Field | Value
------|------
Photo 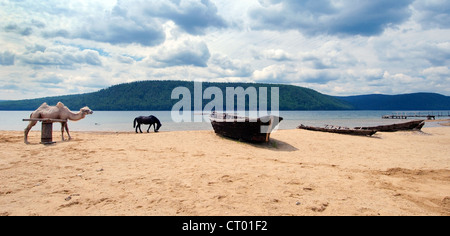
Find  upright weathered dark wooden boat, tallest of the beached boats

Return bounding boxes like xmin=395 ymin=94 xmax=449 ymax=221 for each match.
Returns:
xmin=210 ymin=112 xmax=283 ymax=142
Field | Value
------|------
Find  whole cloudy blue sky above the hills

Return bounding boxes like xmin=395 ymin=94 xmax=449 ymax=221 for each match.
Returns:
xmin=0 ymin=0 xmax=450 ymax=100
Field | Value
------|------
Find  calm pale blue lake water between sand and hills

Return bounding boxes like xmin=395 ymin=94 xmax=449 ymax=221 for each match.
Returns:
xmin=0 ymin=111 xmax=450 ymax=132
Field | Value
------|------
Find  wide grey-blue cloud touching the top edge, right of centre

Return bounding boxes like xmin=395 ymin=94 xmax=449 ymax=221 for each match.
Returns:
xmin=249 ymin=0 xmax=413 ymax=36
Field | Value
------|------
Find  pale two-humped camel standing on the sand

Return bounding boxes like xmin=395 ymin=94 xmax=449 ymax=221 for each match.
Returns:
xmin=25 ymin=102 xmax=94 ymax=144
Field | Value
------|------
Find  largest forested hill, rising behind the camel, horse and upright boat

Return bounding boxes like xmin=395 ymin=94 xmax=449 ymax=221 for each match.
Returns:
xmin=0 ymin=81 xmax=353 ymax=111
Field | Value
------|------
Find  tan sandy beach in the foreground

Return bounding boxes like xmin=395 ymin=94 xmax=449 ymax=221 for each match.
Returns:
xmin=0 ymin=127 xmax=450 ymax=216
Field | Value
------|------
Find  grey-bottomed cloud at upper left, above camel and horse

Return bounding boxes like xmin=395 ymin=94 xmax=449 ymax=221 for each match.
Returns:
xmin=33 ymin=1 xmax=165 ymax=46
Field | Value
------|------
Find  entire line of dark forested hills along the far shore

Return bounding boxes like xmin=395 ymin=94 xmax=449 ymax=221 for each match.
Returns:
xmin=0 ymin=81 xmax=450 ymax=111
